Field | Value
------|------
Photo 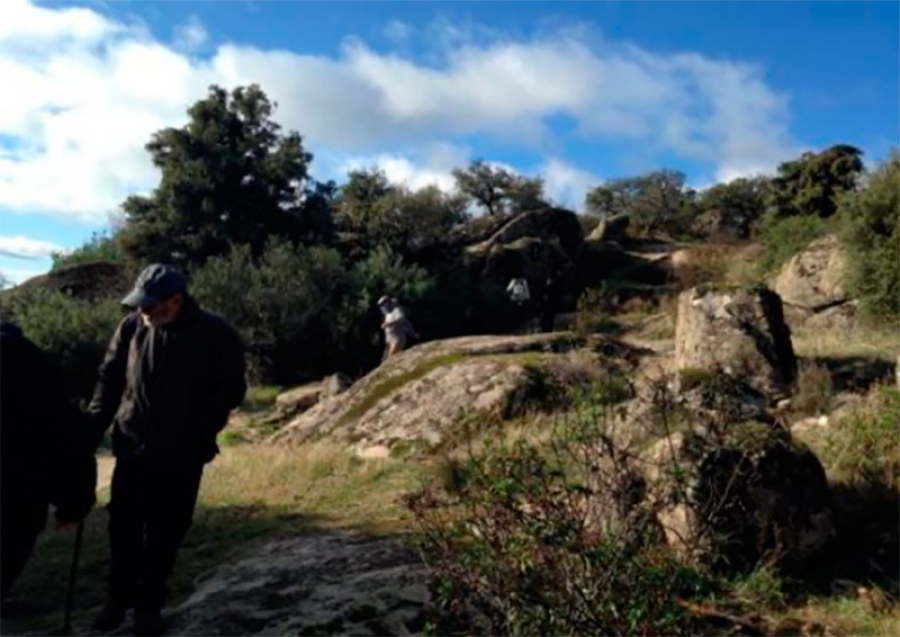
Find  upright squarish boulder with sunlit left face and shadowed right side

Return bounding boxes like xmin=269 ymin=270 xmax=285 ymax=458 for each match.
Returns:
xmin=675 ymin=287 xmax=797 ymax=396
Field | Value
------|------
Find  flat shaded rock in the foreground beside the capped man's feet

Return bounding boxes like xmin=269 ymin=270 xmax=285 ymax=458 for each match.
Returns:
xmin=167 ymin=533 xmax=431 ymax=635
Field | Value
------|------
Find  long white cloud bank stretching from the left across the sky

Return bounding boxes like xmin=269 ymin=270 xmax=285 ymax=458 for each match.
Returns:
xmin=0 ymin=0 xmax=795 ymax=223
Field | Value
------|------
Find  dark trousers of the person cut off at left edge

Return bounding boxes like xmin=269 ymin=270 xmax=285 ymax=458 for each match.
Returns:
xmin=0 ymin=484 xmax=49 ymax=599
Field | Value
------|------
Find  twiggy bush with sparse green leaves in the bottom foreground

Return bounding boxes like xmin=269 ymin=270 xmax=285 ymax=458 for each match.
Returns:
xmin=407 ymin=414 xmax=710 ymax=635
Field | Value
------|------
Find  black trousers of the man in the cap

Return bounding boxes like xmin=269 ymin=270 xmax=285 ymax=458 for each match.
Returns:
xmin=107 ymin=458 xmax=203 ymax=610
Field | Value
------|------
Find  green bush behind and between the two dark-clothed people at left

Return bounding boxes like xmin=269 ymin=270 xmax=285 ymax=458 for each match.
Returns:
xmin=9 ymin=288 xmax=124 ymax=399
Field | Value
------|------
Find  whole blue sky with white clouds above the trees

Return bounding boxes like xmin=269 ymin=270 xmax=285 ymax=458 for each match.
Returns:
xmin=0 ymin=0 xmax=900 ymax=281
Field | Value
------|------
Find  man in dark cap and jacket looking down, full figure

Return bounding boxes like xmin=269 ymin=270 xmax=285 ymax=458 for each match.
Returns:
xmin=88 ymin=264 xmax=246 ymax=635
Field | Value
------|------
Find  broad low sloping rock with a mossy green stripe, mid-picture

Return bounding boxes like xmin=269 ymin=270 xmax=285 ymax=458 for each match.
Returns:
xmin=269 ymin=332 xmax=596 ymax=457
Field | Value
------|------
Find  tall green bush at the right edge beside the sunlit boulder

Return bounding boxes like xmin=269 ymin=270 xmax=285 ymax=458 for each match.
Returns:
xmin=839 ymin=150 xmax=900 ymax=318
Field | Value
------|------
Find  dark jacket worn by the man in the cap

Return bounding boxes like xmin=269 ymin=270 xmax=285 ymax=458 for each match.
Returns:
xmin=88 ymin=296 xmax=247 ymax=462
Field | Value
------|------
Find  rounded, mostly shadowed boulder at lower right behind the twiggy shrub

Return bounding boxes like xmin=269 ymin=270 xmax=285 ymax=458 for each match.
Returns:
xmin=644 ymin=421 xmax=835 ymax=573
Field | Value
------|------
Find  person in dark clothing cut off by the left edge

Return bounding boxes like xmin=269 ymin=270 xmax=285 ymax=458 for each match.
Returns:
xmin=0 ymin=322 xmax=97 ymax=600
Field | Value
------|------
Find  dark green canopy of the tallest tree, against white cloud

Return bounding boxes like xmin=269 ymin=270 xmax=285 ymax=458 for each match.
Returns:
xmin=122 ymin=85 xmax=333 ymax=264
